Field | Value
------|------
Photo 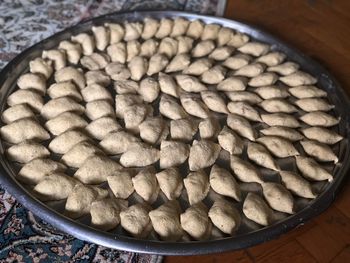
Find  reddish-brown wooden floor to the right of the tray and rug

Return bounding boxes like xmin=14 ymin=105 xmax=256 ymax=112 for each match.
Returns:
xmin=164 ymin=0 xmax=350 ymax=263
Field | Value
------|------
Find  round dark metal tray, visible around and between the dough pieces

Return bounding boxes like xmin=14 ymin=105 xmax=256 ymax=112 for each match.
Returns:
xmin=0 ymin=11 xmax=350 ymax=255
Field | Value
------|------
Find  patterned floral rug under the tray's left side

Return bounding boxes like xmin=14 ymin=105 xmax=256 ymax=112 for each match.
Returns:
xmin=0 ymin=0 xmax=226 ymax=263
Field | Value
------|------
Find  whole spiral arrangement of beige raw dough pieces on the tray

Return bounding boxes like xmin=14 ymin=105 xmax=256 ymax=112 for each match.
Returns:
xmin=1 ymin=18 xmax=342 ymax=240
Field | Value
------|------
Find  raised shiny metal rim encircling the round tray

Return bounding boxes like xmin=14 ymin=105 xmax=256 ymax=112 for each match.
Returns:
xmin=0 ymin=11 xmax=350 ymax=255
